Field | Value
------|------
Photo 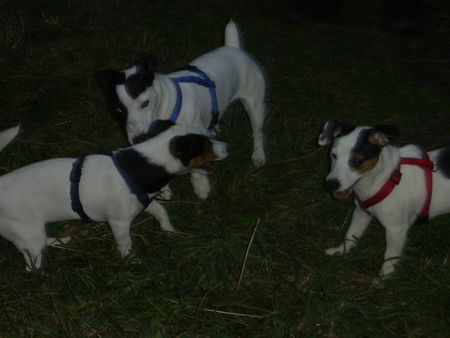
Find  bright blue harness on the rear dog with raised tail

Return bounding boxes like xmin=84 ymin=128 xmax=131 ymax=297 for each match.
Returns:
xmin=170 ymin=65 xmax=219 ymax=131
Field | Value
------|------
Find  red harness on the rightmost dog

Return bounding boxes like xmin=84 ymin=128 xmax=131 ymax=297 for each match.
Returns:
xmin=355 ymin=152 xmax=435 ymax=223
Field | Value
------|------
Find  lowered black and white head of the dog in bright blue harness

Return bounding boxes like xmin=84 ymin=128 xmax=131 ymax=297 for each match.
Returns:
xmin=96 ymin=56 xmax=158 ymax=144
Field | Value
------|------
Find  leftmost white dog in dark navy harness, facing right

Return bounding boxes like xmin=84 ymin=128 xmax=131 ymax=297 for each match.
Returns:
xmin=0 ymin=121 xmax=228 ymax=270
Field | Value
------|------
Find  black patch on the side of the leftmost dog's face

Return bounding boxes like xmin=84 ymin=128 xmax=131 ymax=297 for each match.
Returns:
xmin=169 ymin=134 xmax=212 ymax=166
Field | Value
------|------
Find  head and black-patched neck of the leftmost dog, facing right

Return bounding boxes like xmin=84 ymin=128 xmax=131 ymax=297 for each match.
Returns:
xmin=115 ymin=120 xmax=228 ymax=193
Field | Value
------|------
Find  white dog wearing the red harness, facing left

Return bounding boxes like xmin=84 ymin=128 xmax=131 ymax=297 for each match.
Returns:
xmin=319 ymin=121 xmax=450 ymax=278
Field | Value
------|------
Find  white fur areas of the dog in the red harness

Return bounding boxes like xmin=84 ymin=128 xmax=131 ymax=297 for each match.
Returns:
xmin=320 ymin=127 xmax=450 ymax=282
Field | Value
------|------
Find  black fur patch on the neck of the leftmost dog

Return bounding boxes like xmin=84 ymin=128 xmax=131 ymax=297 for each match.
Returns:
xmin=115 ymin=149 xmax=175 ymax=193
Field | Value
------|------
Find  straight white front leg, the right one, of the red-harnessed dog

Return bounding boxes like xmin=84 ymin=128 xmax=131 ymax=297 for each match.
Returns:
xmin=380 ymin=224 xmax=409 ymax=279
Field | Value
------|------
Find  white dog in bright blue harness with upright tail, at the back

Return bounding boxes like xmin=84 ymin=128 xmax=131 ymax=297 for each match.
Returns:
xmin=97 ymin=21 xmax=266 ymax=199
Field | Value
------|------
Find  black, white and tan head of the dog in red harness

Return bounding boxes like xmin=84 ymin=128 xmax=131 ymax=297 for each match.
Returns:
xmin=319 ymin=121 xmax=400 ymax=199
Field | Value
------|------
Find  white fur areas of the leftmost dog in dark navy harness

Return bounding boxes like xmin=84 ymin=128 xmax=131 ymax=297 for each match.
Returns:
xmin=0 ymin=125 xmax=227 ymax=270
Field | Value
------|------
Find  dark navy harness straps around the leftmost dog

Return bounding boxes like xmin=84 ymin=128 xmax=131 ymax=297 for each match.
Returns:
xmin=70 ymin=153 xmax=153 ymax=223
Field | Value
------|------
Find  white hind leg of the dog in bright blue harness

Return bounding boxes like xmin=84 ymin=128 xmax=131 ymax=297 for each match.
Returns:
xmin=241 ymin=96 xmax=266 ymax=167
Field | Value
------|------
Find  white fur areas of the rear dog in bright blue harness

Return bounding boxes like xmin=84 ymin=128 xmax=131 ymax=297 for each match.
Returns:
xmin=116 ymin=21 xmax=266 ymax=198
